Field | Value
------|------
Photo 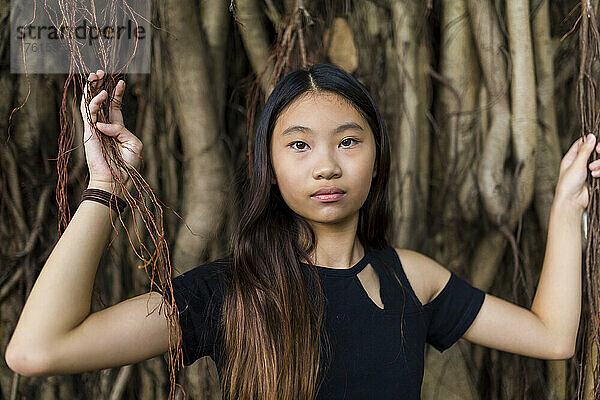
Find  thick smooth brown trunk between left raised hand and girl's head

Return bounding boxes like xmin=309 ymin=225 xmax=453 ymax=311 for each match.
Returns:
xmin=167 ymin=1 xmax=231 ymax=272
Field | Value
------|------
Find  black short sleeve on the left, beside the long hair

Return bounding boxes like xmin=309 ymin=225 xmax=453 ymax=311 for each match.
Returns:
xmin=152 ymin=263 xmax=223 ymax=367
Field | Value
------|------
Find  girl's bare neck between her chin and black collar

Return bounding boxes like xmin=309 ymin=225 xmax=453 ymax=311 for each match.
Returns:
xmin=309 ymin=213 xmax=364 ymax=269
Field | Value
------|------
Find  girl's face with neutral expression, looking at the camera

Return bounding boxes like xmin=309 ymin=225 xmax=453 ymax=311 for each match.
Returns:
xmin=270 ymin=92 xmax=376 ymax=227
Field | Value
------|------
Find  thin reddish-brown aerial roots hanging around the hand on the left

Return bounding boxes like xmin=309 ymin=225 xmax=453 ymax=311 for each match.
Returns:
xmin=2 ymin=0 xmax=189 ymax=400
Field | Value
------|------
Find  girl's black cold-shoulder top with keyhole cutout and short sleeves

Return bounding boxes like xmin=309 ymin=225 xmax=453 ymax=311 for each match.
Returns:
xmin=154 ymin=246 xmax=485 ymax=400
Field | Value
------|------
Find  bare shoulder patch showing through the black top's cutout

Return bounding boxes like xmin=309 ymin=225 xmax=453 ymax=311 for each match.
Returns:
xmin=394 ymin=248 xmax=451 ymax=304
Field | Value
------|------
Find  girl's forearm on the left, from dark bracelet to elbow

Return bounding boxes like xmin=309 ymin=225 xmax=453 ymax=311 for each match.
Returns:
xmin=10 ymin=184 xmax=118 ymax=350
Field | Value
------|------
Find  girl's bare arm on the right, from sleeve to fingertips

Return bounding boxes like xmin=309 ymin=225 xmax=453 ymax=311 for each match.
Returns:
xmin=463 ymin=135 xmax=600 ymax=359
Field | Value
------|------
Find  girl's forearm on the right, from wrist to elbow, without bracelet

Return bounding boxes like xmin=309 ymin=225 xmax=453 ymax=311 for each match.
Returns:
xmin=531 ymin=197 xmax=583 ymax=349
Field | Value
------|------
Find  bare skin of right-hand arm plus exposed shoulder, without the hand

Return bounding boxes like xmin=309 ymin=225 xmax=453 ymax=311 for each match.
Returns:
xmin=396 ymin=191 xmax=582 ymax=360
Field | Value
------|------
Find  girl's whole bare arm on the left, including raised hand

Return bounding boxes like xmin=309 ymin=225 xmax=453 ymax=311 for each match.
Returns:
xmin=5 ymin=70 xmax=176 ymax=376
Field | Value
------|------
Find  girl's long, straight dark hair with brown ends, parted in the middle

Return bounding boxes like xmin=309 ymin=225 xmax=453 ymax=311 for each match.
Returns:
xmin=221 ymin=64 xmax=398 ymax=399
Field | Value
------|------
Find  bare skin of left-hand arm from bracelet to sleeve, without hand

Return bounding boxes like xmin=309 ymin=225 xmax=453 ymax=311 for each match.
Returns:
xmin=5 ymin=183 xmax=168 ymax=376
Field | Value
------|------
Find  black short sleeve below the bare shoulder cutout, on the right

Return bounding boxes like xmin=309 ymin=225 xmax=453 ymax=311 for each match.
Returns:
xmin=424 ymin=272 xmax=485 ymax=352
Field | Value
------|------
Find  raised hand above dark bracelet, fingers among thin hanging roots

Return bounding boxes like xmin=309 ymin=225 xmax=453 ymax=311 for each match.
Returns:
xmin=80 ymin=70 xmax=143 ymax=192
